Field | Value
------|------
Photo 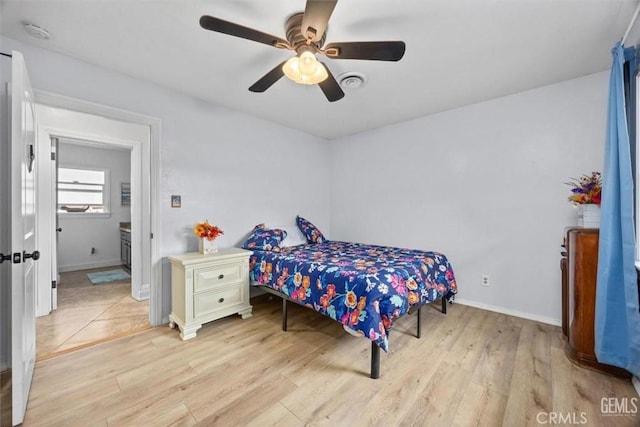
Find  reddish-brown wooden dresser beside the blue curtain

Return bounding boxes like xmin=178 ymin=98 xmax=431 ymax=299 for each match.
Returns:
xmin=560 ymin=227 xmax=631 ymax=378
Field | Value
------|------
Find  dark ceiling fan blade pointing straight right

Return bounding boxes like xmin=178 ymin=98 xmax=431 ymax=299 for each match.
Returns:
xmin=324 ymin=41 xmax=406 ymax=61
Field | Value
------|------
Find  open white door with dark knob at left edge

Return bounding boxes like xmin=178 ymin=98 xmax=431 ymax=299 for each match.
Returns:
xmin=11 ymin=51 xmax=39 ymax=425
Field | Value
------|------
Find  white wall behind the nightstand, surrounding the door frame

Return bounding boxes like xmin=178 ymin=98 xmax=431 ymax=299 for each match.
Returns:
xmin=2 ymin=38 xmax=329 ymax=318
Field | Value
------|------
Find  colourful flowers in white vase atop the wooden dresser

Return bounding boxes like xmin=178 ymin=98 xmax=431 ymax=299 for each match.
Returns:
xmin=567 ymin=172 xmax=602 ymax=228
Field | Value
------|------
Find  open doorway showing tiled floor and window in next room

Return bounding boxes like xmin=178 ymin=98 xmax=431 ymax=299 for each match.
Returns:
xmin=36 ymin=137 xmax=151 ymax=360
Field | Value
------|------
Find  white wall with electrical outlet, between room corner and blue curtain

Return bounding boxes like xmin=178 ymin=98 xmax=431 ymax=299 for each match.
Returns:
xmin=330 ymin=73 xmax=608 ymax=323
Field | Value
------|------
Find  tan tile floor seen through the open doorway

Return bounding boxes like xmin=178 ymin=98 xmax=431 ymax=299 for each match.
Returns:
xmin=36 ymin=266 xmax=151 ymax=360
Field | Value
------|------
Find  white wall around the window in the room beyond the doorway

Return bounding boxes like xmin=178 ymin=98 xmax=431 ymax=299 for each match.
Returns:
xmin=58 ymin=141 xmax=131 ymax=271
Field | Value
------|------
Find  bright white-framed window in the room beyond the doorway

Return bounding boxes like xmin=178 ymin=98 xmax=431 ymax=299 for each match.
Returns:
xmin=58 ymin=167 xmax=109 ymax=214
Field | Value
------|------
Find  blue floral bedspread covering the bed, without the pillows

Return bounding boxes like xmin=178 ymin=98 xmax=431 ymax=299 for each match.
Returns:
xmin=250 ymin=241 xmax=457 ymax=351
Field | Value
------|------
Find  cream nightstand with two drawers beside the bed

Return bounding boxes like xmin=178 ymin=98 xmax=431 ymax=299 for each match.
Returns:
xmin=169 ymin=248 xmax=252 ymax=340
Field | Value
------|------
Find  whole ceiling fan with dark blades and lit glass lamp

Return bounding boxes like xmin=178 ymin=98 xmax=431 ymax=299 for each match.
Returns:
xmin=200 ymin=0 xmax=405 ymax=102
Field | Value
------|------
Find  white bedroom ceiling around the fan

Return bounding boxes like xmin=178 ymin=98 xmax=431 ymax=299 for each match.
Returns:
xmin=0 ymin=0 xmax=638 ymax=139
